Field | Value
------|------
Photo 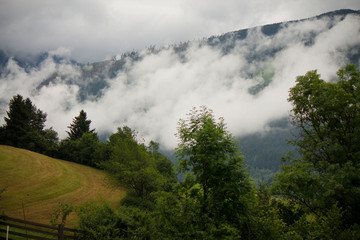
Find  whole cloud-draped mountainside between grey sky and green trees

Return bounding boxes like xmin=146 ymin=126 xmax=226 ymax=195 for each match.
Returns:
xmin=0 ymin=9 xmax=360 ymax=182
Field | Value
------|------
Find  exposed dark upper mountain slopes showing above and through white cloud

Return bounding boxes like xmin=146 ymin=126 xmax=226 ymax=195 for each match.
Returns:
xmin=0 ymin=9 xmax=360 ymax=100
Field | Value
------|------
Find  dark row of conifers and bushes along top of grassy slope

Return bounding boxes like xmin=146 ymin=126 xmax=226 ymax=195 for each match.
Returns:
xmin=0 ymin=98 xmax=166 ymax=172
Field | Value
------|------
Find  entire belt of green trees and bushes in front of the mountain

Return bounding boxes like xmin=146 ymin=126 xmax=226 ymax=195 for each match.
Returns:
xmin=0 ymin=65 xmax=360 ymax=239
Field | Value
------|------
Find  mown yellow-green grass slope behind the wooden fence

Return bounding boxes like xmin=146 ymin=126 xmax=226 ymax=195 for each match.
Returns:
xmin=0 ymin=145 xmax=126 ymax=227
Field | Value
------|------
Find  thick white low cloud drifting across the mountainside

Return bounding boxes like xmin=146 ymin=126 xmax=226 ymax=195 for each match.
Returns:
xmin=0 ymin=13 xmax=360 ymax=149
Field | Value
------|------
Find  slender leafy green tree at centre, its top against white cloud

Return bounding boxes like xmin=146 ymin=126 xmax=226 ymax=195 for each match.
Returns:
xmin=176 ymin=106 xmax=254 ymax=225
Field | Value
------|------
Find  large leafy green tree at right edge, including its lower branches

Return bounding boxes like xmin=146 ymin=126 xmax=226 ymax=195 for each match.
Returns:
xmin=273 ymin=65 xmax=360 ymax=228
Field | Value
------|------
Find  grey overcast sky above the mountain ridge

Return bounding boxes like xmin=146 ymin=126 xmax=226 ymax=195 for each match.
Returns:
xmin=0 ymin=0 xmax=360 ymax=63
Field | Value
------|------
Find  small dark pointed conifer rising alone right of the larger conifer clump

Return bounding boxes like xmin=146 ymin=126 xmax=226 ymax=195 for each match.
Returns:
xmin=67 ymin=110 xmax=95 ymax=140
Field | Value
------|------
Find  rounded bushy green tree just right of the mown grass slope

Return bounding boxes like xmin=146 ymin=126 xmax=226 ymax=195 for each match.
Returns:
xmin=102 ymin=126 xmax=171 ymax=200
